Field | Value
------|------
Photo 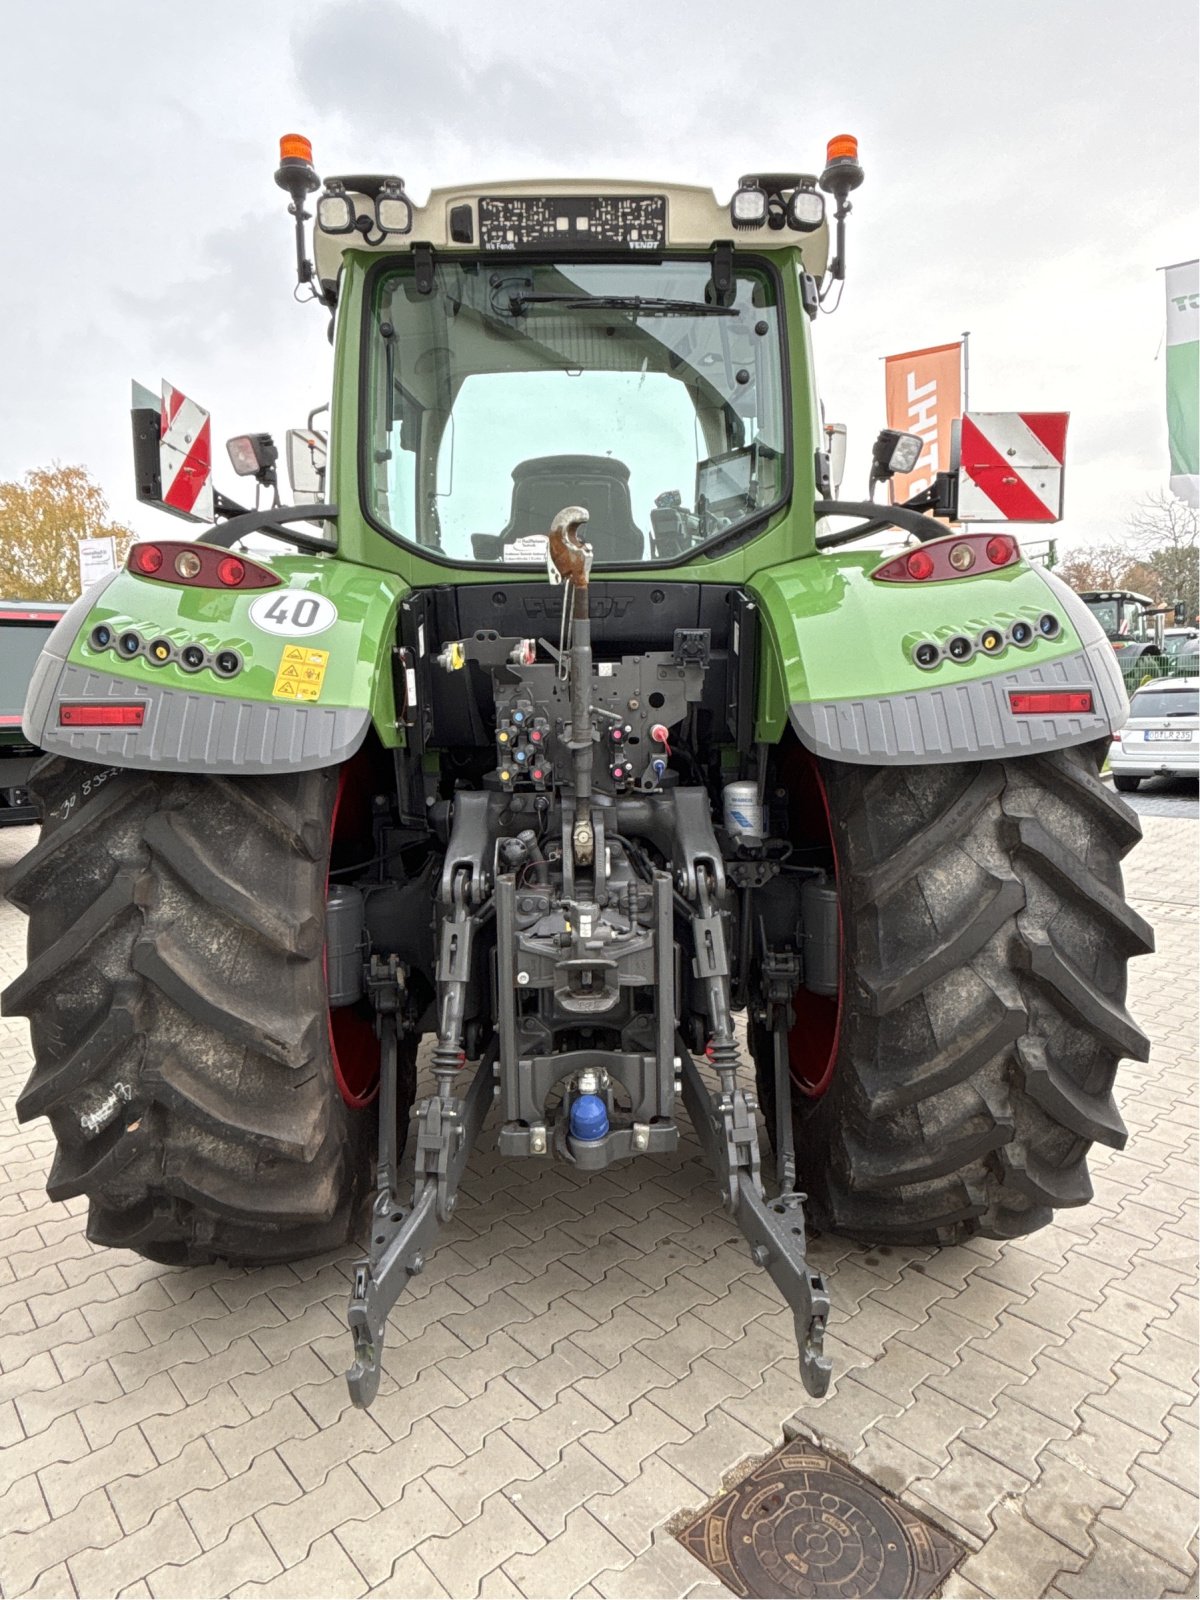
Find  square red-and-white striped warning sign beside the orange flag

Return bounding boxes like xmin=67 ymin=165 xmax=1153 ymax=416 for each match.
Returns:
xmin=958 ymin=411 xmax=1070 ymax=522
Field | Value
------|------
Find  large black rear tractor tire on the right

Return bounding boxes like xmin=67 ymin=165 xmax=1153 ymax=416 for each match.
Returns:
xmin=752 ymin=741 xmax=1154 ymax=1245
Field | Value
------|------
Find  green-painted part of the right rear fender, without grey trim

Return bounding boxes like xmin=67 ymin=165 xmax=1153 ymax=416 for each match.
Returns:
xmin=747 ymin=549 xmax=1082 ymax=742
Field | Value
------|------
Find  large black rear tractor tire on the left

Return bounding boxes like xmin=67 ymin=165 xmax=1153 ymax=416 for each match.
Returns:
xmin=3 ymin=757 xmax=404 ymax=1264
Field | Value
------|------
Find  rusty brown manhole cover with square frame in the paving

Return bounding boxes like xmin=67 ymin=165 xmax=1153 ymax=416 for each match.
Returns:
xmin=678 ymin=1440 xmax=963 ymax=1600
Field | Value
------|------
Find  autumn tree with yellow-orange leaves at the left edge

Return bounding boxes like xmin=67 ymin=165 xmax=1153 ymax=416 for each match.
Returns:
xmin=0 ymin=461 xmax=134 ymax=600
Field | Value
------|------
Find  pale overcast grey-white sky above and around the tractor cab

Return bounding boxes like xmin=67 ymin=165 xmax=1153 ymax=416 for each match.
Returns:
xmin=0 ymin=0 xmax=1200 ymax=544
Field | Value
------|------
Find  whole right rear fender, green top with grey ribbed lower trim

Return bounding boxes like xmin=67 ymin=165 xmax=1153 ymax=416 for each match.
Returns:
xmin=747 ymin=549 xmax=1128 ymax=765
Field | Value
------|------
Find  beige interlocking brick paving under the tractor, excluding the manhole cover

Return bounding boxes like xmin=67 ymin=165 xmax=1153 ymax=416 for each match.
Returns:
xmin=0 ymin=816 xmax=1200 ymax=1600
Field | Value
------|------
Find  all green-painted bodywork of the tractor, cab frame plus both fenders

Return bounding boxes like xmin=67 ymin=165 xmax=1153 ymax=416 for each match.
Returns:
xmin=56 ymin=248 xmax=1082 ymax=747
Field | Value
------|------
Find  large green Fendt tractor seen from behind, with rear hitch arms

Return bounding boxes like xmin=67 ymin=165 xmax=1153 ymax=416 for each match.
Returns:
xmin=5 ymin=136 xmax=1150 ymax=1405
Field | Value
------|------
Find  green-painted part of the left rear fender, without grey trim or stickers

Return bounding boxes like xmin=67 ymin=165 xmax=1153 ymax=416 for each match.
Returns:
xmin=67 ymin=546 xmax=408 ymax=747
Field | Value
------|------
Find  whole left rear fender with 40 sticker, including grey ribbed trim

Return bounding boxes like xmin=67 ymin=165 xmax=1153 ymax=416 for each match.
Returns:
xmin=24 ymin=544 xmax=408 ymax=773
